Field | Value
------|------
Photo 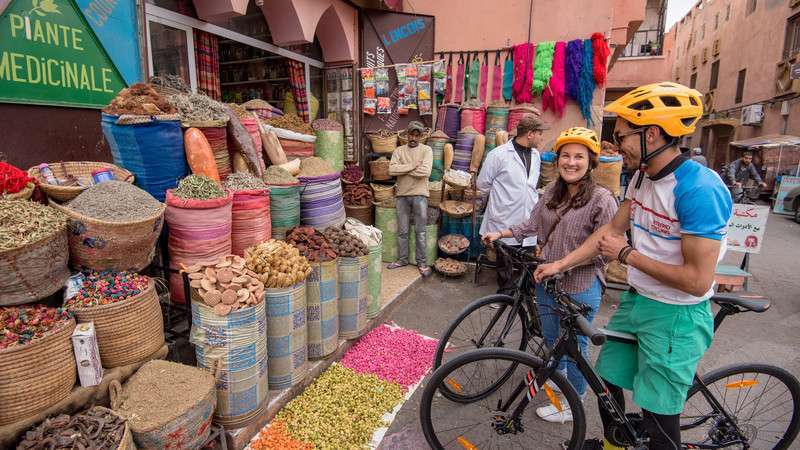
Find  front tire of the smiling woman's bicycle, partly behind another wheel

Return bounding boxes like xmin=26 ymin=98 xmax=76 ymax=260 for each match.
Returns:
xmin=433 ymin=294 xmax=530 ymax=403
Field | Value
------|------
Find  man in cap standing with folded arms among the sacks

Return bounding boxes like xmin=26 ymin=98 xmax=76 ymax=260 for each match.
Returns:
xmin=388 ymin=120 xmax=433 ymax=277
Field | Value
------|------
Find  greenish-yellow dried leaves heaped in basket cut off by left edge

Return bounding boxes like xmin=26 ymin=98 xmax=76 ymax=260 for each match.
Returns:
xmin=0 ymin=200 xmax=67 ymax=252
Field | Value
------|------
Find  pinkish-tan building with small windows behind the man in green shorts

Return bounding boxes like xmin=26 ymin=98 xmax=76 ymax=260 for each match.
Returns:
xmin=666 ymin=0 xmax=800 ymax=169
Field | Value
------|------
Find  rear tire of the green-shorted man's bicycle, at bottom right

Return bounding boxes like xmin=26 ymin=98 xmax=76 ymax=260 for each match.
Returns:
xmin=681 ymin=363 xmax=800 ymax=450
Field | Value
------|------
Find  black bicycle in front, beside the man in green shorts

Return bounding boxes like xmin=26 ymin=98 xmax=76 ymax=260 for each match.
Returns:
xmin=420 ymin=280 xmax=800 ymax=450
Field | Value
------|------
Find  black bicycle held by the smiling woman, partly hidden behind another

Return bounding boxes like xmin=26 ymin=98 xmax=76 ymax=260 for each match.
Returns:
xmin=433 ymin=241 xmax=546 ymax=403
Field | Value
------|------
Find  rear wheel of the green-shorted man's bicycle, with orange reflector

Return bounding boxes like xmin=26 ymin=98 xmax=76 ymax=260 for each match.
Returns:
xmin=681 ymin=364 xmax=800 ymax=449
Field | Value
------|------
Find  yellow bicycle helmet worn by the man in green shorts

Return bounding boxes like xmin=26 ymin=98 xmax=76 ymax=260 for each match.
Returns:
xmin=606 ymin=81 xmax=703 ymax=137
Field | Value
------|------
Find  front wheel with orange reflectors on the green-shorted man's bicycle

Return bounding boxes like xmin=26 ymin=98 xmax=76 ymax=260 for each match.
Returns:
xmin=420 ymin=348 xmax=586 ymax=450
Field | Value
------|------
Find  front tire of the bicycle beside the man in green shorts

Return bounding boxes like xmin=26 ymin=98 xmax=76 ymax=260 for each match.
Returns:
xmin=420 ymin=347 xmax=586 ymax=450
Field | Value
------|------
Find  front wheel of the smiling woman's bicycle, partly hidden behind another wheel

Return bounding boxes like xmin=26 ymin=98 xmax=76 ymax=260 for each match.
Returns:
xmin=433 ymin=294 xmax=529 ymax=403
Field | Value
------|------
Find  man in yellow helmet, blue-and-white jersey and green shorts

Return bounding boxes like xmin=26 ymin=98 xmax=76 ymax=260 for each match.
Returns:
xmin=535 ymin=82 xmax=733 ymax=450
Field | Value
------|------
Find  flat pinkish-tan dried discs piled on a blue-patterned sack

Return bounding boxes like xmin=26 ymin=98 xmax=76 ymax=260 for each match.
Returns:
xmin=186 ymin=255 xmax=264 ymax=316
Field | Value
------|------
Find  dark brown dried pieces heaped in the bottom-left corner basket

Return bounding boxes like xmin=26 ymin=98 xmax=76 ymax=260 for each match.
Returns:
xmin=17 ymin=406 xmax=125 ymax=450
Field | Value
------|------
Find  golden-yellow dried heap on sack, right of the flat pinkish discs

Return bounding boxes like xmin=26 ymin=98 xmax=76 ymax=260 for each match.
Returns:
xmin=244 ymin=239 xmax=311 ymax=288
